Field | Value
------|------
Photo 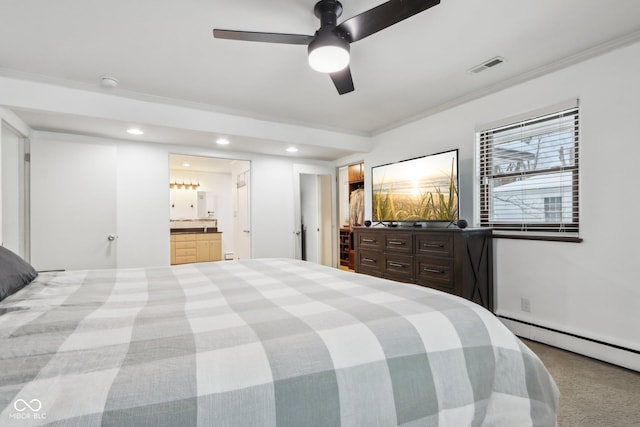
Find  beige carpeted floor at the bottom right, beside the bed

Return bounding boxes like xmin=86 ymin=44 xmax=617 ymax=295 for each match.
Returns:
xmin=523 ymin=339 xmax=640 ymax=427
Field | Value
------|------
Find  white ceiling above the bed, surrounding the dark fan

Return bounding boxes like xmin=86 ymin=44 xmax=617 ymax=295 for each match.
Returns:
xmin=0 ymin=0 xmax=640 ymax=160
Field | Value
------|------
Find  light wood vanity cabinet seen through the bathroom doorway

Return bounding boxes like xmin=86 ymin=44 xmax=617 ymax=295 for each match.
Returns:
xmin=171 ymin=233 xmax=222 ymax=265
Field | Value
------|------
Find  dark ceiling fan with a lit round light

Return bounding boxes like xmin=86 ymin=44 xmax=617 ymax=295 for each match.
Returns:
xmin=213 ymin=0 xmax=440 ymax=95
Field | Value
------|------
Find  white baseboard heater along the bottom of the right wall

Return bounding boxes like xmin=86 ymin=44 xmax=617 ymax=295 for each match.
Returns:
xmin=498 ymin=317 xmax=640 ymax=372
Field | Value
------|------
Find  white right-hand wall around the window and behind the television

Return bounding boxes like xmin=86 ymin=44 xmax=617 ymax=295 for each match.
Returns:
xmin=338 ymin=39 xmax=640 ymax=370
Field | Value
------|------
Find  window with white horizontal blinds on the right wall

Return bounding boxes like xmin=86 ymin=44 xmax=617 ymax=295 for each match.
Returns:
xmin=477 ymin=101 xmax=580 ymax=241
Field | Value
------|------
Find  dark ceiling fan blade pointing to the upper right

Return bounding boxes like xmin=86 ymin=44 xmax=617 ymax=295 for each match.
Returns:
xmin=335 ymin=0 xmax=440 ymax=43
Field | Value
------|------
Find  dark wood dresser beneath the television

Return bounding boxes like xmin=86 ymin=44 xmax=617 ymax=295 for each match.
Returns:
xmin=353 ymin=227 xmax=493 ymax=312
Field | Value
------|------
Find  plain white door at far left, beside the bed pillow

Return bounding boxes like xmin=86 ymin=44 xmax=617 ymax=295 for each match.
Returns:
xmin=31 ymin=140 xmax=117 ymax=270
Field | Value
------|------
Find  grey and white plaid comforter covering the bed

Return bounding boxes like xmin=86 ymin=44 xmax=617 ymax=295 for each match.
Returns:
xmin=0 ymin=259 xmax=558 ymax=427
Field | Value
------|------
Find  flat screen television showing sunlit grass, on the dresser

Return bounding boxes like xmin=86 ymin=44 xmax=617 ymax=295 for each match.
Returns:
xmin=371 ymin=149 xmax=459 ymax=223
